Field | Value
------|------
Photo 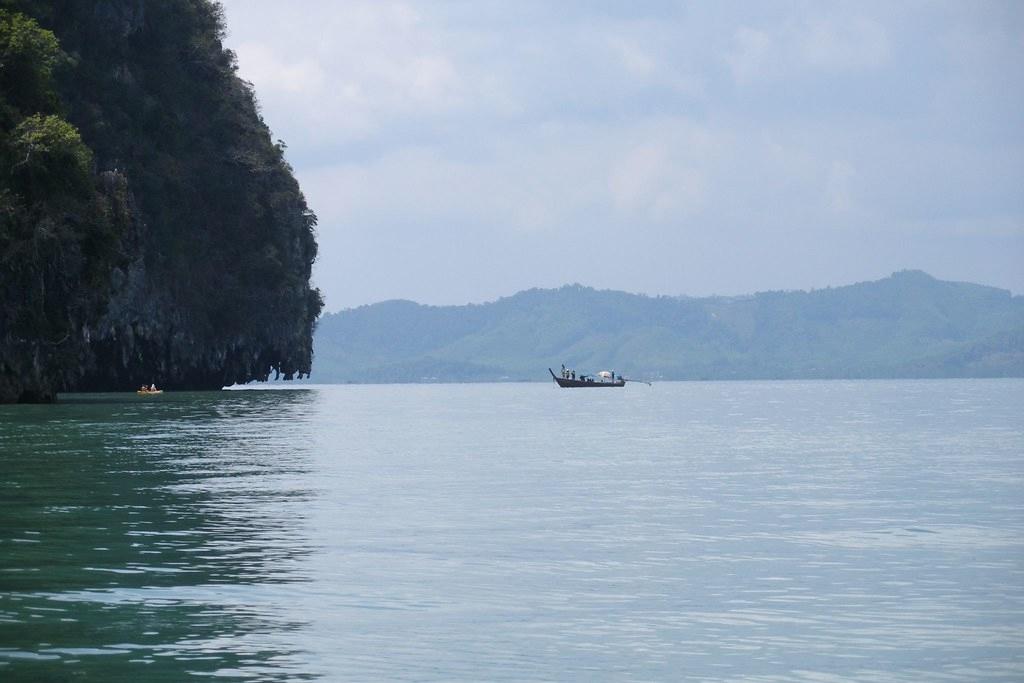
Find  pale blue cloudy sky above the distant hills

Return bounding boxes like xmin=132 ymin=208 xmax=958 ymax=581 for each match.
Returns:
xmin=223 ymin=0 xmax=1024 ymax=311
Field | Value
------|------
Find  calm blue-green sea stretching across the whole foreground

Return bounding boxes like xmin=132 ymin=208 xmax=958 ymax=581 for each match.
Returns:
xmin=0 ymin=380 xmax=1024 ymax=682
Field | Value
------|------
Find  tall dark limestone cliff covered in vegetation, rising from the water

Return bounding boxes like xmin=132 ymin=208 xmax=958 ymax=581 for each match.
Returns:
xmin=0 ymin=0 xmax=322 ymax=401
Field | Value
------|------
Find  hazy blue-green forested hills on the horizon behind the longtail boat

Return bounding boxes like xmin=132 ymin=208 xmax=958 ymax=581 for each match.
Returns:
xmin=314 ymin=271 xmax=1024 ymax=382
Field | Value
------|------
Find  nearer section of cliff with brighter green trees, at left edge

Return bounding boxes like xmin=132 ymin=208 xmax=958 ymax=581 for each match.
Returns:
xmin=0 ymin=9 xmax=125 ymax=400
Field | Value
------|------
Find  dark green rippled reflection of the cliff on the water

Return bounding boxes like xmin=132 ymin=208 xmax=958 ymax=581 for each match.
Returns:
xmin=0 ymin=391 xmax=315 ymax=681
